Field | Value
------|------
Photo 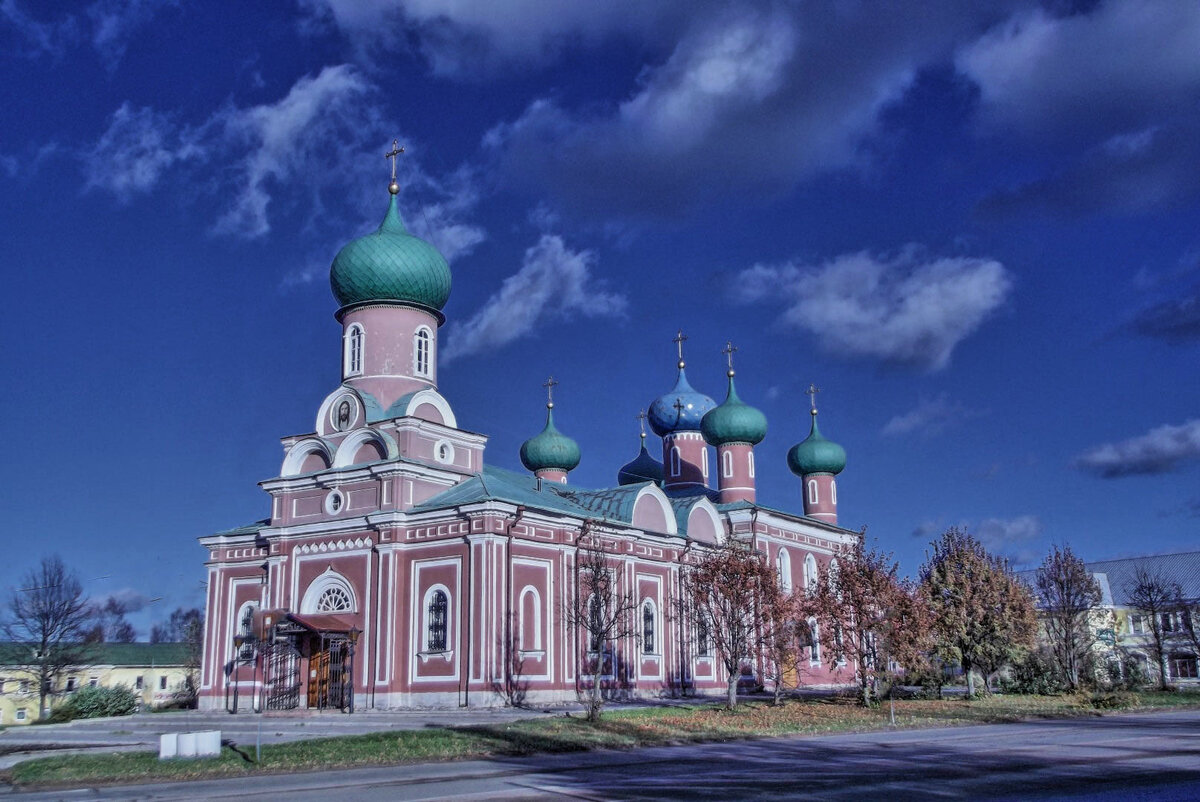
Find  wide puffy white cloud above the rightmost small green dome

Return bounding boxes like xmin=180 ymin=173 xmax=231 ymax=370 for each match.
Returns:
xmin=731 ymin=246 xmax=1012 ymax=371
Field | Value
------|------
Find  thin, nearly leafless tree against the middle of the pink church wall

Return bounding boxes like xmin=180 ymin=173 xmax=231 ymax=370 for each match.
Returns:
xmin=563 ymin=534 xmax=638 ymax=722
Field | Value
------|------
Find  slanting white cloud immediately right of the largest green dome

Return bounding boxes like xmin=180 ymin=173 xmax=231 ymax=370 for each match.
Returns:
xmin=442 ymin=234 xmax=628 ymax=360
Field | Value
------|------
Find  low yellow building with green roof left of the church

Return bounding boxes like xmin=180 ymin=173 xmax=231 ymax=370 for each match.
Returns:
xmin=0 ymin=644 xmax=196 ymax=726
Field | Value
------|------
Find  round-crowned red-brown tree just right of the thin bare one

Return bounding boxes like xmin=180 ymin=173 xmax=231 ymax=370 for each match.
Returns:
xmin=680 ymin=543 xmax=787 ymax=710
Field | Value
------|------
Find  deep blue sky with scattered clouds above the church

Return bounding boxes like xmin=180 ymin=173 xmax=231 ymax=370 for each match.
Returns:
xmin=0 ymin=0 xmax=1200 ymax=634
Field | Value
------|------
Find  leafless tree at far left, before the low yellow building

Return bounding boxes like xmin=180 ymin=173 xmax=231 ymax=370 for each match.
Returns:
xmin=4 ymin=555 xmax=91 ymax=718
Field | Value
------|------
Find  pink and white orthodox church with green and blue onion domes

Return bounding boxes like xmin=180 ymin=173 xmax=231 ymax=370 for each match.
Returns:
xmin=200 ymin=168 xmax=859 ymax=711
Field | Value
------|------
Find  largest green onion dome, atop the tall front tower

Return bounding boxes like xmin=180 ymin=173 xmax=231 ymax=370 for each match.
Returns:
xmin=329 ymin=194 xmax=450 ymax=311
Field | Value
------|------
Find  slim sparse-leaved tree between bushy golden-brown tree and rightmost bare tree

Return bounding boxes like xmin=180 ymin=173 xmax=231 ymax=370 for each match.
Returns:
xmin=1034 ymin=545 xmax=1100 ymax=690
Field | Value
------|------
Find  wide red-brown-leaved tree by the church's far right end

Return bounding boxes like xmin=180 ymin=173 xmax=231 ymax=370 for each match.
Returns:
xmin=804 ymin=538 xmax=929 ymax=705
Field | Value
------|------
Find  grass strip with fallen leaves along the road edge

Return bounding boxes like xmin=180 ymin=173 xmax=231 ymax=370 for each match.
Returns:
xmin=7 ymin=693 xmax=1200 ymax=788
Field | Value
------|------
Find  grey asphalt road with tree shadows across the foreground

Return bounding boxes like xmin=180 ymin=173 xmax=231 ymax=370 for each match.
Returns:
xmin=10 ymin=711 xmax=1200 ymax=802
